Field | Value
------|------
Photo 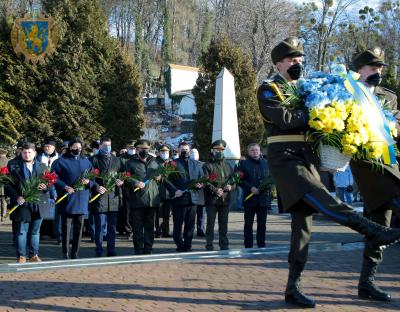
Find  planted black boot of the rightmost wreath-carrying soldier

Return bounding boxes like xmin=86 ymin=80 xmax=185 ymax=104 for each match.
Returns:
xmin=358 ymin=259 xmax=392 ymax=302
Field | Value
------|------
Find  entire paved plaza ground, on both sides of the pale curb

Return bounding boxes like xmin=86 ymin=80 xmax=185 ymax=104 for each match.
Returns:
xmin=0 ymin=208 xmax=400 ymax=311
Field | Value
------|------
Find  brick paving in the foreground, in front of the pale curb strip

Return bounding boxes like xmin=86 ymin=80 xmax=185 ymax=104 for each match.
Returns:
xmin=0 ymin=246 xmax=400 ymax=312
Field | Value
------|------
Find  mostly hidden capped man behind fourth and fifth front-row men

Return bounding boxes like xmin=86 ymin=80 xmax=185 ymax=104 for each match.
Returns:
xmin=155 ymin=144 xmax=171 ymax=237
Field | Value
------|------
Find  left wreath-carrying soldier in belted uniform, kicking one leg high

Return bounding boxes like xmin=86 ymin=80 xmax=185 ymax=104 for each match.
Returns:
xmin=257 ymin=37 xmax=400 ymax=307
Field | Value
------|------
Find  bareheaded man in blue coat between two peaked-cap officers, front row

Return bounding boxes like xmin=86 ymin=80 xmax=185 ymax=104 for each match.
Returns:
xmin=166 ymin=142 xmax=204 ymax=252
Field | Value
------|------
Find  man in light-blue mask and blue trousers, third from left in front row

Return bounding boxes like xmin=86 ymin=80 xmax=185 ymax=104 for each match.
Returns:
xmin=90 ymin=137 xmax=123 ymax=257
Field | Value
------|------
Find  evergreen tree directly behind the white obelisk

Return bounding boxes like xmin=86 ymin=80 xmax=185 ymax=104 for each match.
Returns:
xmin=193 ymin=38 xmax=264 ymax=155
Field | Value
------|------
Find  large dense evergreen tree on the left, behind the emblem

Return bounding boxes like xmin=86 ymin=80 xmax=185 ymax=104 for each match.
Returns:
xmin=0 ymin=0 xmax=143 ymax=144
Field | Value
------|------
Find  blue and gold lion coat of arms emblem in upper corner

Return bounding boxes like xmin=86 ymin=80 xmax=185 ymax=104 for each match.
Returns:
xmin=11 ymin=16 xmax=56 ymax=64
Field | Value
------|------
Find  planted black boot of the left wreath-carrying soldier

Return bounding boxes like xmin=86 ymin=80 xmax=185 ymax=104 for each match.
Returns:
xmin=285 ymin=264 xmax=315 ymax=308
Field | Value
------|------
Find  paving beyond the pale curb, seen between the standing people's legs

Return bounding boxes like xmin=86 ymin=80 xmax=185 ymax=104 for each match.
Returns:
xmin=0 ymin=210 xmax=362 ymax=264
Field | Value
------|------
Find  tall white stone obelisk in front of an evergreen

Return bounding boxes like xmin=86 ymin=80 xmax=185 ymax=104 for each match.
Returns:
xmin=212 ymin=68 xmax=240 ymax=160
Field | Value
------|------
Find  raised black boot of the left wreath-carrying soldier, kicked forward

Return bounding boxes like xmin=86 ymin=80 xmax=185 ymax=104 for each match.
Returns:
xmin=344 ymin=213 xmax=400 ymax=247
